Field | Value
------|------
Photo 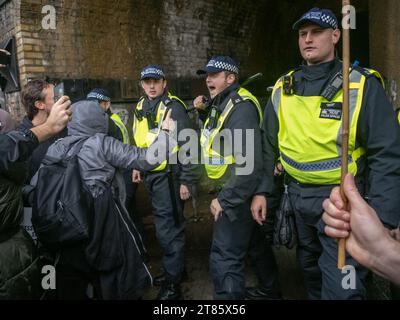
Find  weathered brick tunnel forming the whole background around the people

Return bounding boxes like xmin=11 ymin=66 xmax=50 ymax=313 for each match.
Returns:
xmin=0 ymin=0 xmax=400 ymax=299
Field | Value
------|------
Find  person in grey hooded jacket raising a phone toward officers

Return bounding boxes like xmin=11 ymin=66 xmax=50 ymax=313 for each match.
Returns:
xmin=39 ymin=101 xmax=176 ymax=299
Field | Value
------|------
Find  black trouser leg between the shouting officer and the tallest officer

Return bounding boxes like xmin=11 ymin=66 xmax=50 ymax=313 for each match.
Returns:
xmin=248 ymin=225 xmax=280 ymax=296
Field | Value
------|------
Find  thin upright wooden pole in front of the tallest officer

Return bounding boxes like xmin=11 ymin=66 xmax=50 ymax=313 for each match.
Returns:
xmin=338 ymin=0 xmax=350 ymax=269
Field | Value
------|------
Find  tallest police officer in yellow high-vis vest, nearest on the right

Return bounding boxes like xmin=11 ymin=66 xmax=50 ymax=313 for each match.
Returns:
xmin=253 ymin=8 xmax=400 ymax=299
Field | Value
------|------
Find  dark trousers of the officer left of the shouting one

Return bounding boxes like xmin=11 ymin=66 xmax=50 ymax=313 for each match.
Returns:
xmin=145 ymin=172 xmax=185 ymax=284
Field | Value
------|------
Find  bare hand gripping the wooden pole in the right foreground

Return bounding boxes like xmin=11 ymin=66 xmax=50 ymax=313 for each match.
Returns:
xmin=322 ymin=174 xmax=391 ymax=268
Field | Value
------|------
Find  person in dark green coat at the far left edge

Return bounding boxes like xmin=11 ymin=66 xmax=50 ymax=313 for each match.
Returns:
xmin=0 ymin=110 xmax=40 ymax=300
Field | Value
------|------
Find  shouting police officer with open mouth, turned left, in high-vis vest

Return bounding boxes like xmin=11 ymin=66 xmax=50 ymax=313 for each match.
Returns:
xmin=193 ymin=56 xmax=262 ymax=299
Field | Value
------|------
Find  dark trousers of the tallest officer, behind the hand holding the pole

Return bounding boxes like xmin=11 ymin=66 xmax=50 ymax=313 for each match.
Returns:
xmin=289 ymin=182 xmax=368 ymax=300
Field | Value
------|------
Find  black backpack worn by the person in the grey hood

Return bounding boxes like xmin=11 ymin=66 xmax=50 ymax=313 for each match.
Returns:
xmin=32 ymin=139 xmax=91 ymax=248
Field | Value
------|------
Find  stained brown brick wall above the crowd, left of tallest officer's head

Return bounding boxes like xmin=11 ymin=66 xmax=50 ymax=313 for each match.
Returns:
xmin=0 ymin=0 xmax=378 ymax=122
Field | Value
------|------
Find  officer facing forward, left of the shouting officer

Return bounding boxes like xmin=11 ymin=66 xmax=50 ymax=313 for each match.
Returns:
xmin=132 ymin=65 xmax=200 ymax=300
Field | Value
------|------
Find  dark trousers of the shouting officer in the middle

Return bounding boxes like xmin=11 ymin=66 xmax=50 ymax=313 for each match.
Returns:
xmin=210 ymin=203 xmax=255 ymax=300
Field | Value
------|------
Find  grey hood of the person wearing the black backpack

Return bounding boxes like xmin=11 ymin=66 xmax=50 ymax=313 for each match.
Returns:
xmin=68 ymin=100 xmax=109 ymax=137
